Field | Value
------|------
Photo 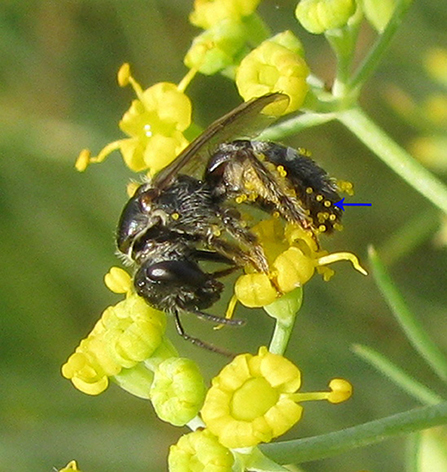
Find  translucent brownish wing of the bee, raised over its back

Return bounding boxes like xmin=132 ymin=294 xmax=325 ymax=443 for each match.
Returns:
xmin=153 ymin=93 xmax=289 ymax=189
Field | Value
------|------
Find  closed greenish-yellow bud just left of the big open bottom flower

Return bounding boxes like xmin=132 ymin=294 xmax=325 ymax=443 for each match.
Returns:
xmin=150 ymin=357 xmax=205 ymax=426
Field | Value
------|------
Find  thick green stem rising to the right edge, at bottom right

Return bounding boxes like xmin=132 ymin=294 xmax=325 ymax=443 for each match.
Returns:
xmin=259 ymin=402 xmax=447 ymax=464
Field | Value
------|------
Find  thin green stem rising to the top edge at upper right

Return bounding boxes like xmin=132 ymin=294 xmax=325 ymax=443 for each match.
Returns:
xmin=348 ymin=0 xmax=412 ymax=93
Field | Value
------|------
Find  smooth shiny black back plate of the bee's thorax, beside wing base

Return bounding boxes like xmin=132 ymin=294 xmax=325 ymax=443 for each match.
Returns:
xmin=116 ymin=184 xmax=160 ymax=256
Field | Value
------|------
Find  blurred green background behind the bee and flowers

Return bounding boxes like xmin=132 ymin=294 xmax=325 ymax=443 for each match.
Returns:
xmin=0 ymin=0 xmax=447 ymax=472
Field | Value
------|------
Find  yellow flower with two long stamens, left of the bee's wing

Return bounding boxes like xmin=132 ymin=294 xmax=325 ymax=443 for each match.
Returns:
xmin=76 ymin=64 xmax=192 ymax=175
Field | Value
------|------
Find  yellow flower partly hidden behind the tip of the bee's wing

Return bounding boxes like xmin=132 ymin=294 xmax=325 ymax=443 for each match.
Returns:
xmin=236 ymin=32 xmax=309 ymax=113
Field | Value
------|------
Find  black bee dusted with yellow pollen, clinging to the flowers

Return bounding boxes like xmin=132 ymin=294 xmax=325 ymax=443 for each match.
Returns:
xmin=116 ymin=93 xmax=341 ymax=352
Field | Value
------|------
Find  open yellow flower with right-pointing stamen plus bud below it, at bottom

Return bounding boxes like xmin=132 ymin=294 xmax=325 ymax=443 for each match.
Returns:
xmin=169 ymin=347 xmax=352 ymax=472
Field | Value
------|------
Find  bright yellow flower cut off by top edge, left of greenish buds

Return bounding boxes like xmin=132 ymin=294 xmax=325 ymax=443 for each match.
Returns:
xmin=189 ymin=0 xmax=261 ymax=29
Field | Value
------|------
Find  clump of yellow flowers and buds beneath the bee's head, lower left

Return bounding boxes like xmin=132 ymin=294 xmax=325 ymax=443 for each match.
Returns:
xmin=62 ymin=267 xmax=205 ymax=426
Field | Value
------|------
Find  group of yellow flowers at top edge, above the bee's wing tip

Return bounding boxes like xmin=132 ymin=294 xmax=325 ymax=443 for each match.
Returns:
xmin=185 ymin=0 xmax=309 ymax=113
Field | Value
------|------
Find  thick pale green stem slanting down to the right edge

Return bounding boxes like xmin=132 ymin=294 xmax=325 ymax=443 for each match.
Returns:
xmin=337 ymin=107 xmax=447 ymax=213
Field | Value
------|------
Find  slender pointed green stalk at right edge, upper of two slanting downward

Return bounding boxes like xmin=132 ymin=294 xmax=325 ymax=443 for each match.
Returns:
xmin=369 ymin=247 xmax=447 ymax=382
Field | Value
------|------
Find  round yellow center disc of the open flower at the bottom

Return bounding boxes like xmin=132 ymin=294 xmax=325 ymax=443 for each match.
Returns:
xmin=231 ymin=377 xmax=279 ymax=421
